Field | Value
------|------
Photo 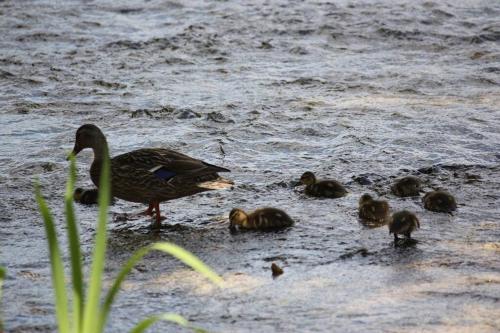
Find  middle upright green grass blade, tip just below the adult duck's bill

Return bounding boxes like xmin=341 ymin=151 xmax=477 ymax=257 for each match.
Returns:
xmin=64 ymin=154 xmax=84 ymax=332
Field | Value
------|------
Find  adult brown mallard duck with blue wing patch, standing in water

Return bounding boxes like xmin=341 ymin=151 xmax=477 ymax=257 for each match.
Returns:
xmin=73 ymin=124 xmax=233 ymax=226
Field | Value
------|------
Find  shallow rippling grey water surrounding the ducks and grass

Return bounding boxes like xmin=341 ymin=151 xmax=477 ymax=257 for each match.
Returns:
xmin=0 ymin=0 xmax=500 ymax=332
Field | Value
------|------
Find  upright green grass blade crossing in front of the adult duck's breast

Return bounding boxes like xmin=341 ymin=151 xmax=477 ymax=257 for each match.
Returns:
xmin=83 ymin=151 xmax=111 ymax=333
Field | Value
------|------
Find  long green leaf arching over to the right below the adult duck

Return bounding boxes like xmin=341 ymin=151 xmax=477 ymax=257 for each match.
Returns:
xmin=100 ymin=242 xmax=223 ymax=330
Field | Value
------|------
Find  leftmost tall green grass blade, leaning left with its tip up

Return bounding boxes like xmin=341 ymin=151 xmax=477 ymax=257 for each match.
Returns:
xmin=35 ymin=184 xmax=70 ymax=333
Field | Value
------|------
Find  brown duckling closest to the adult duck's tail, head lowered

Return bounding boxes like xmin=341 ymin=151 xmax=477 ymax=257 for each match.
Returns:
xmin=229 ymin=207 xmax=294 ymax=230
